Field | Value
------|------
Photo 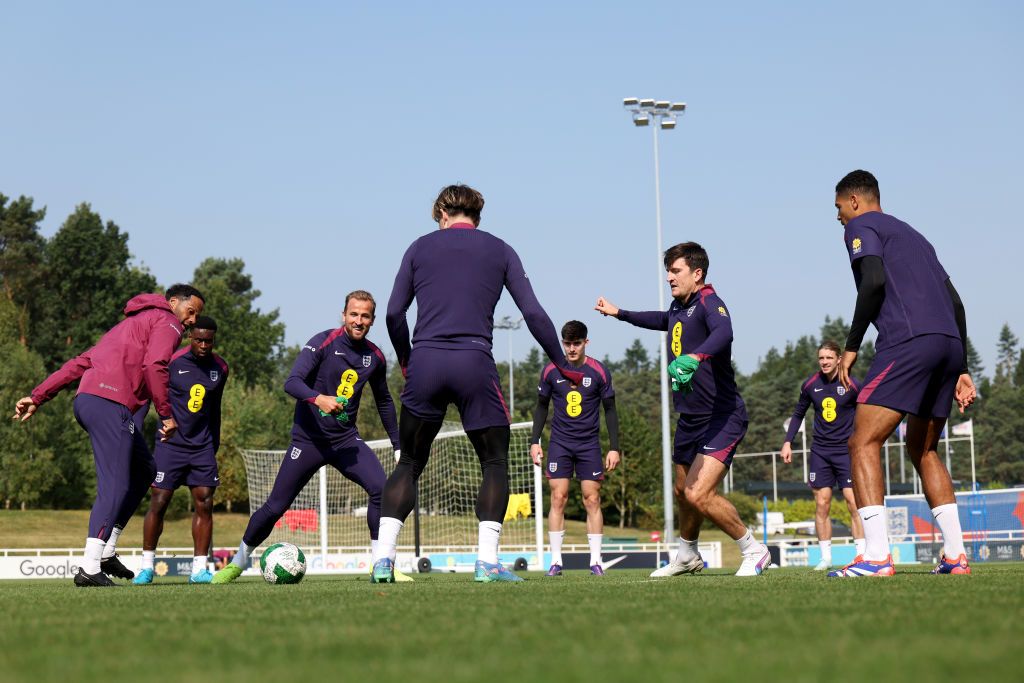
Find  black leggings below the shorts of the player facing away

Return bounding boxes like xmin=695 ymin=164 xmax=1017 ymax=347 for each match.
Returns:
xmin=381 ymin=411 xmax=511 ymax=522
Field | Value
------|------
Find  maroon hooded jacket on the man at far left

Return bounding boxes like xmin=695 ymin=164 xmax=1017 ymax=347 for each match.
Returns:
xmin=32 ymin=294 xmax=183 ymax=419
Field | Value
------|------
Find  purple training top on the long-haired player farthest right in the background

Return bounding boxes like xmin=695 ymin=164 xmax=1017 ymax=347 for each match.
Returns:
xmin=785 ymin=373 xmax=860 ymax=453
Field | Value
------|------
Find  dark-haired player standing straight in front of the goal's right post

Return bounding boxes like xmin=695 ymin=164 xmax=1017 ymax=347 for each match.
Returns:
xmin=529 ymin=321 xmax=620 ymax=577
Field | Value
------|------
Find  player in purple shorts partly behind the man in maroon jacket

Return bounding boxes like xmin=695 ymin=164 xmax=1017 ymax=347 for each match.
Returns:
xmin=132 ymin=315 xmax=227 ymax=586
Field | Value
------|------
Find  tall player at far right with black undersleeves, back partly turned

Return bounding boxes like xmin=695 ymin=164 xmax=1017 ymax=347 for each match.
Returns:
xmin=828 ymin=171 xmax=977 ymax=577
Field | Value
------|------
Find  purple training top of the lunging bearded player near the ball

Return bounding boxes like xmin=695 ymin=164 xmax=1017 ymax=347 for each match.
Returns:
xmin=285 ymin=328 xmax=399 ymax=450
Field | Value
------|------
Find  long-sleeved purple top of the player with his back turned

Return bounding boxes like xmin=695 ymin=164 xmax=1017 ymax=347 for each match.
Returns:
xmin=387 ymin=223 xmax=571 ymax=385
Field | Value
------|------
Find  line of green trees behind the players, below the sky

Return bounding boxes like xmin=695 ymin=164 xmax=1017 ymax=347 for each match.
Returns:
xmin=0 ymin=194 xmax=1024 ymax=527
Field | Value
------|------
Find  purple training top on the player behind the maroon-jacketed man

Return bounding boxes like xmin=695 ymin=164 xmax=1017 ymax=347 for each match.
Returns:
xmin=167 ymin=348 xmax=227 ymax=452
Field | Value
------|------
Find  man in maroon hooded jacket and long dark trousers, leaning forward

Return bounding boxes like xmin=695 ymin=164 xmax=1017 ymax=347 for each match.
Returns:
xmin=14 ymin=285 xmax=204 ymax=587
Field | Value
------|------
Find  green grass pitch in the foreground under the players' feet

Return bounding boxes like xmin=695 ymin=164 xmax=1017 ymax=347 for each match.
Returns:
xmin=0 ymin=563 xmax=1024 ymax=683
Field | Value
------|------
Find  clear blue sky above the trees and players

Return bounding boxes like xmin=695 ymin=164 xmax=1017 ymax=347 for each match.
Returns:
xmin=0 ymin=2 xmax=1024 ymax=372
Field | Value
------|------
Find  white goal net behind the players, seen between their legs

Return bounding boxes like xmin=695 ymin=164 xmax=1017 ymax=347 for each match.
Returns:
xmin=242 ymin=422 xmax=540 ymax=552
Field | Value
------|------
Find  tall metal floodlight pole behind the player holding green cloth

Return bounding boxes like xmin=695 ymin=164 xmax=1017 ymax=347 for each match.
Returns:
xmin=623 ymin=97 xmax=686 ymax=543
